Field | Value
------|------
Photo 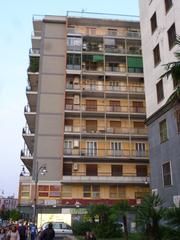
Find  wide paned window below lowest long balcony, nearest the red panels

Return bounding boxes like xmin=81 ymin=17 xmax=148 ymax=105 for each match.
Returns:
xmin=83 ymin=184 xmax=100 ymax=198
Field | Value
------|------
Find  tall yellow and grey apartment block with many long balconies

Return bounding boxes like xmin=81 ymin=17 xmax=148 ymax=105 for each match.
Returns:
xmin=19 ymin=13 xmax=149 ymax=218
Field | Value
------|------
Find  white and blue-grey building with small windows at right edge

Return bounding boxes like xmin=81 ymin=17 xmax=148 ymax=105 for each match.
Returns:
xmin=139 ymin=0 xmax=180 ymax=206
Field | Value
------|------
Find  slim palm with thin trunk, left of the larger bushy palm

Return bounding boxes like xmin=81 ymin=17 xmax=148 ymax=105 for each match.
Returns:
xmin=114 ymin=200 xmax=131 ymax=240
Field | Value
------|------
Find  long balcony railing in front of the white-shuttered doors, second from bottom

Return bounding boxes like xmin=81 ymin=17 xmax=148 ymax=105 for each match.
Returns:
xmin=64 ymin=148 xmax=148 ymax=158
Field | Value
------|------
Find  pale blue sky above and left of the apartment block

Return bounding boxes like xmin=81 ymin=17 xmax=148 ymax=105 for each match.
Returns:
xmin=0 ymin=0 xmax=139 ymax=197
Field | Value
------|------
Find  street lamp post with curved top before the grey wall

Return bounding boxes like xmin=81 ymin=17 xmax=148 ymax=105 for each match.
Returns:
xmin=32 ymin=161 xmax=47 ymax=223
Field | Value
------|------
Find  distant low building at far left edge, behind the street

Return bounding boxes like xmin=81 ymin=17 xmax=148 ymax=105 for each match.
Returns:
xmin=0 ymin=196 xmax=18 ymax=211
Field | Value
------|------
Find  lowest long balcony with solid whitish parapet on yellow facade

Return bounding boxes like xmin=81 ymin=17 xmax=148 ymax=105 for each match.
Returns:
xmin=62 ymin=171 xmax=148 ymax=185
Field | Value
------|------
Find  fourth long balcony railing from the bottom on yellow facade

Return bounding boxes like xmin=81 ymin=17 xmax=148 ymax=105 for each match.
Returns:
xmin=65 ymin=104 xmax=145 ymax=113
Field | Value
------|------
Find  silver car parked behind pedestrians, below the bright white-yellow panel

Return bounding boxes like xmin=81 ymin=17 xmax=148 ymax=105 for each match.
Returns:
xmin=40 ymin=222 xmax=73 ymax=236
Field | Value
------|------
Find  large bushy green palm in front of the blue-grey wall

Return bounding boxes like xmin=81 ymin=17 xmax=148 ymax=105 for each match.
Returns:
xmin=137 ymin=193 xmax=165 ymax=240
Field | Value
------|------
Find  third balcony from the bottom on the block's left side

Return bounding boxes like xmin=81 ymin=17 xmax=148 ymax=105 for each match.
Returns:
xmin=24 ymin=105 xmax=36 ymax=132
